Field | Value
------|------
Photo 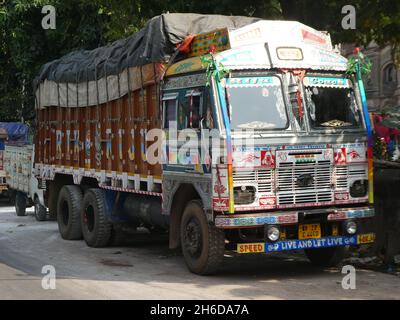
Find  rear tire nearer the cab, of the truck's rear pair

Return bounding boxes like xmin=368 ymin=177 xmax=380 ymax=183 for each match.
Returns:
xmin=81 ymin=189 xmax=112 ymax=248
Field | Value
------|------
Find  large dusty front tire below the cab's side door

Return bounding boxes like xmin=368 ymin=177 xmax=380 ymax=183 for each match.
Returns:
xmin=180 ymin=200 xmax=225 ymax=275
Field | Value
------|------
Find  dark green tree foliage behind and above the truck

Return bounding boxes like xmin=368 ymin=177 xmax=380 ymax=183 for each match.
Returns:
xmin=0 ymin=0 xmax=400 ymax=121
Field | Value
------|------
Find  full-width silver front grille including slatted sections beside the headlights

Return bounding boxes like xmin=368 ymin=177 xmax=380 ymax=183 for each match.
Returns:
xmin=233 ymin=160 xmax=368 ymax=208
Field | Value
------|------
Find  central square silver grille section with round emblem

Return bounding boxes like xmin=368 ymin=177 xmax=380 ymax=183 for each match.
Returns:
xmin=276 ymin=161 xmax=333 ymax=206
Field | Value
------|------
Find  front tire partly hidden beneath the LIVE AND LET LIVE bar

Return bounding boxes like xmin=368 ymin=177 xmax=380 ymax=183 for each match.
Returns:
xmin=304 ymin=247 xmax=345 ymax=267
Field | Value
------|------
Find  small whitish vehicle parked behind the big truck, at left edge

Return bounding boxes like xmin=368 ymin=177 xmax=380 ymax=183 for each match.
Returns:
xmin=4 ymin=145 xmax=47 ymax=221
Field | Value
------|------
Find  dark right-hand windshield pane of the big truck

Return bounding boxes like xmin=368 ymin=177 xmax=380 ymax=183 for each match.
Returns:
xmin=304 ymin=77 xmax=361 ymax=129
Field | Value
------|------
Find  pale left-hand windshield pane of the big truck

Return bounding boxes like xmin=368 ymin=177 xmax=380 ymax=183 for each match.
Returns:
xmin=227 ymin=76 xmax=288 ymax=130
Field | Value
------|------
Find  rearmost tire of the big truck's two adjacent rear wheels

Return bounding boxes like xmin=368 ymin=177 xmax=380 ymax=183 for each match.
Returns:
xmin=57 ymin=186 xmax=82 ymax=240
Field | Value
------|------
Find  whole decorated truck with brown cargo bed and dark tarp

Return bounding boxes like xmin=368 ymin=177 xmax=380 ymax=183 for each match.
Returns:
xmin=35 ymin=14 xmax=374 ymax=274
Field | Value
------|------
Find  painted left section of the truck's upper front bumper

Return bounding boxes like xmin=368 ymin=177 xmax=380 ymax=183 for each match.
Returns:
xmin=215 ymin=212 xmax=298 ymax=228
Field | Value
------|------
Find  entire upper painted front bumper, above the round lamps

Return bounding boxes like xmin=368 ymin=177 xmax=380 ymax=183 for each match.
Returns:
xmin=214 ymin=207 xmax=375 ymax=229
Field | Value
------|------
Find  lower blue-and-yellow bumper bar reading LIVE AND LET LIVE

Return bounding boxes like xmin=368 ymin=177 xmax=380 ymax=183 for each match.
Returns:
xmin=236 ymin=233 xmax=375 ymax=253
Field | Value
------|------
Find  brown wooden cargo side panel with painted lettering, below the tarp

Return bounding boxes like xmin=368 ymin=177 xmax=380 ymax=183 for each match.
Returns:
xmin=36 ymin=84 xmax=162 ymax=186
